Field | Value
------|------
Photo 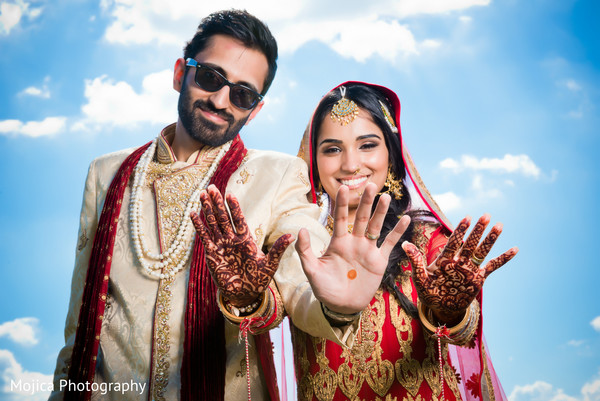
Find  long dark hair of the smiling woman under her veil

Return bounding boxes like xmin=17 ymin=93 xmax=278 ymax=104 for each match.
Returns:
xmin=310 ymin=83 xmax=433 ymax=317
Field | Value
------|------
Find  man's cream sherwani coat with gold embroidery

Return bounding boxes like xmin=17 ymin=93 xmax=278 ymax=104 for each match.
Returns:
xmin=51 ymin=125 xmax=354 ymax=400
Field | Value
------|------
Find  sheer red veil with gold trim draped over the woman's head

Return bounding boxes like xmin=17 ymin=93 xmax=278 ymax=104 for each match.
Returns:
xmin=298 ymin=81 xmax=507 ymax=401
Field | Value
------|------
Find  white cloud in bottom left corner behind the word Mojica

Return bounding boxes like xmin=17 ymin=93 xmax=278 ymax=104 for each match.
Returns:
xmin=0 ymin=349 xmax=52 ymax=401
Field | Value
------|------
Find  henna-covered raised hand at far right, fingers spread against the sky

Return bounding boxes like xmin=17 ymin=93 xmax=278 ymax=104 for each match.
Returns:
xmin=402 ymin=214 xmax=518 ymax=323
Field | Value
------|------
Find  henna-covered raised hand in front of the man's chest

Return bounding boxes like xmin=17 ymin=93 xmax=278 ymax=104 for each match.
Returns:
xmin=191 ymin=185 xmax=294 ymax=307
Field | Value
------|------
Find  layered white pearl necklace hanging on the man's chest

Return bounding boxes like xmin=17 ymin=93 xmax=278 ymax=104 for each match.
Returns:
xmin=129 ymin=140 xmax=231 ymax=279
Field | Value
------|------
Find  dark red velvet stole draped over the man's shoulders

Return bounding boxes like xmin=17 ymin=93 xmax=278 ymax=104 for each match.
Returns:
xmin=65 ymin=136 xmax=278 ymax=400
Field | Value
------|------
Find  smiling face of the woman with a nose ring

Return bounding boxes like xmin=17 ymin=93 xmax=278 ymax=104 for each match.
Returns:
xmin=316 ymin=109 xmax=389 ymax=208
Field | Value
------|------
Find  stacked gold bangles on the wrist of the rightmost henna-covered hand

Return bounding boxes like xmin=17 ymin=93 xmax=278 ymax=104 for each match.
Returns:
xmin=417 ymin=300 xmax=479 ymax=346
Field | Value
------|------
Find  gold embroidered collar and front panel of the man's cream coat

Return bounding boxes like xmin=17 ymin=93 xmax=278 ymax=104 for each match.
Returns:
xmin=146 ymin=148 xmax=219 ymax=401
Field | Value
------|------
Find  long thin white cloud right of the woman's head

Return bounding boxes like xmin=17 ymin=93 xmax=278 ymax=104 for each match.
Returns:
xmin=440 ymin=154 xmax=541 ymax=179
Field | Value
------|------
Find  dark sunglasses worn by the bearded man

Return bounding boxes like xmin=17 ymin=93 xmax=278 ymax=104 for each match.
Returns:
xmin=185 ymin=58 xmax=263 ymax=110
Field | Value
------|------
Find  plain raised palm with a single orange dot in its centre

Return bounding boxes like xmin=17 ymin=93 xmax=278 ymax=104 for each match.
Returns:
xmin=296 ymin=183 xmax=410 ymax=314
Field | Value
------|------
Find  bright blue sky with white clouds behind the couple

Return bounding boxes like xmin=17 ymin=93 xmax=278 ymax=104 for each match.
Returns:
xmin=0 ymin=0 xmax=600 ymax=401
